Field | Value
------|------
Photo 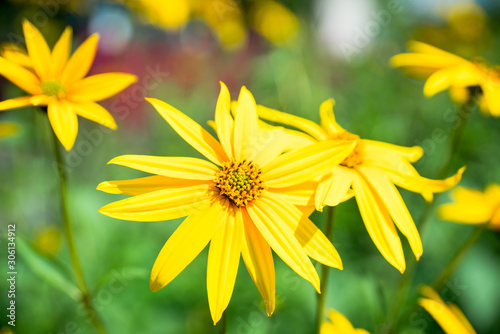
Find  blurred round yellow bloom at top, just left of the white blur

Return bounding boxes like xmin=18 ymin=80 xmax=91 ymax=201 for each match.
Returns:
xmin=251 ymin=0 xmax=299 ymax=45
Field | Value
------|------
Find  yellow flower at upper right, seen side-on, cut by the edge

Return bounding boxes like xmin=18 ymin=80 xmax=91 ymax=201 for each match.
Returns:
xmin=391 ymin=41 xmax=500 ymax=117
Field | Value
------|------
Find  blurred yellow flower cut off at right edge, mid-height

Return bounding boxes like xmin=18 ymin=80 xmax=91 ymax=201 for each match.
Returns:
xmin=438 ymin=183 xmax=500 ymax=230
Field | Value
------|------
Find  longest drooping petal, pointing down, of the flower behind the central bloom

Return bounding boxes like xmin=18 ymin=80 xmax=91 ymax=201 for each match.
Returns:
xmin=353 ymin=174 xmax=406 ymax=273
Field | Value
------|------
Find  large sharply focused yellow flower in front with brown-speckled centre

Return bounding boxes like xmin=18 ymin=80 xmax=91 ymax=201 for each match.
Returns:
xmin=97 ymin=84 xmax=354 ymax=323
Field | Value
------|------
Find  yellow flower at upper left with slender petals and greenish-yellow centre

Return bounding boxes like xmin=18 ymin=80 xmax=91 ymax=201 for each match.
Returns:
xmin=0 ymin=20 xmax=136 ymax=151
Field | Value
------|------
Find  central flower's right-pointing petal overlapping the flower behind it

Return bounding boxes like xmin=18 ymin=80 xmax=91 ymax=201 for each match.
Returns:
xmin=262 ymin=141 xmax=356 ymax=188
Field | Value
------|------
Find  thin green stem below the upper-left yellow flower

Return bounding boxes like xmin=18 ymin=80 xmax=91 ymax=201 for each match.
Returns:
xmin=51 ymin=130 xmax=106 ymax=334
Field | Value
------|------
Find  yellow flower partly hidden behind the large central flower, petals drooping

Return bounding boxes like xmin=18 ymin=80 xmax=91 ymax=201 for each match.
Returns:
xmin=258 ymin=99 xmax=464 ymax=272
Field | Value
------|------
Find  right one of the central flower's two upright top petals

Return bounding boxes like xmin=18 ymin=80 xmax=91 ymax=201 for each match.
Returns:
xmin=233 ymin=87 xmax=259 ymax=161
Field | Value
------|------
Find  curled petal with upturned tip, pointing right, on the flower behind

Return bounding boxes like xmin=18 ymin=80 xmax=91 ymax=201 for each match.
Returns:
xmin=387 ymin=167 xmax=465 ymax=194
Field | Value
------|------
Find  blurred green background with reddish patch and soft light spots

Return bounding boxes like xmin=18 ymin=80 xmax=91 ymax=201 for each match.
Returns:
xmin=0 ymin=0 xmax=500 ymax=334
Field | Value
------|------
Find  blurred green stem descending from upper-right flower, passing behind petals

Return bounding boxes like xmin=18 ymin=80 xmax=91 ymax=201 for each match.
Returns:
xmin=385 ymin=95 xmax=476 ymax=333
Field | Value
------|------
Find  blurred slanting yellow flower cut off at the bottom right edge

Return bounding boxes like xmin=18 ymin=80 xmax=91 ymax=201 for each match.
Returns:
xmin=418 ymin=286 xmax=476 ymax=334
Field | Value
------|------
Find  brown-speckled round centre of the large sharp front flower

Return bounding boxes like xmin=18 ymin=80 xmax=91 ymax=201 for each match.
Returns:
xmin=215 ymin=160 xmax=264 ymax=208
